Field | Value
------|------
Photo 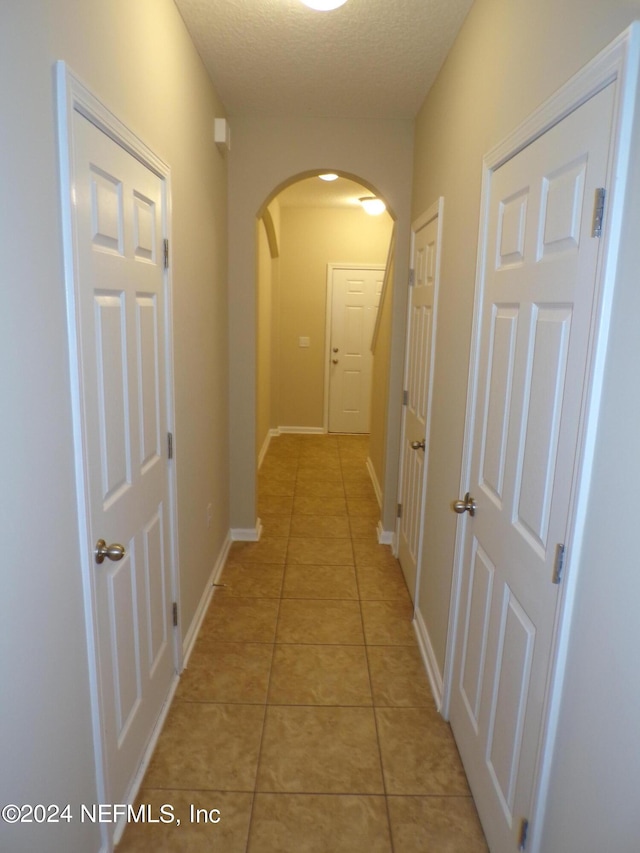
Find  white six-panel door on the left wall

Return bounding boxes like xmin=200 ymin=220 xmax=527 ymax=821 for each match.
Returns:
xmin=74 ymin=112 xmax=174 ymax=802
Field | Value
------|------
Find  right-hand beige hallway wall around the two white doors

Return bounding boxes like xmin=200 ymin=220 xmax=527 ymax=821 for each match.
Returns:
xmin=413 ymin=0 xmax=640 ymax=853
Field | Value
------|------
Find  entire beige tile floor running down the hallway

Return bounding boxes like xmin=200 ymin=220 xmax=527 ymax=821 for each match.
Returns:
xmin=118 ymin=436 xmax=487 ymax=853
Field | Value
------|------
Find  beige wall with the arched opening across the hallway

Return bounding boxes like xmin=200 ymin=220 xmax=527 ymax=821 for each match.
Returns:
xmin=229 ymin=116 xmax=413 ymax=529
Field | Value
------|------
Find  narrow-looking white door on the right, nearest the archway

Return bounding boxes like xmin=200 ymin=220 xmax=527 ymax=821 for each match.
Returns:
xmin=398 ymin=214 xmax=439 ymax=602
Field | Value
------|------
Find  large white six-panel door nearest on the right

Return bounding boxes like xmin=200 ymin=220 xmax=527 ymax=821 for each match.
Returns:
xmin=451 ymin=81 xmax=613 ymax=853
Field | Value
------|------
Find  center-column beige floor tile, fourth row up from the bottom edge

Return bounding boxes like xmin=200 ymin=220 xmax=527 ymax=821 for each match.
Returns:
xmin=276 ymin=599 xmax=364 ymax=645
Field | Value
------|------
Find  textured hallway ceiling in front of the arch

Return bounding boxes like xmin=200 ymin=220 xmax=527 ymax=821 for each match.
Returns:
xmin=175 ymin=0 xmax=472 ymax=119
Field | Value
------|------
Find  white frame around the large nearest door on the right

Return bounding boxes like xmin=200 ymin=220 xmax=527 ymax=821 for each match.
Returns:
xmin=441 ymin=23 xmax=640 ymax=853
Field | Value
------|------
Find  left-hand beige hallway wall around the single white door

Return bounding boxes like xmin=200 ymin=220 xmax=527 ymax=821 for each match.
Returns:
xmin=0 ymin=0 xmax=229 ymax=853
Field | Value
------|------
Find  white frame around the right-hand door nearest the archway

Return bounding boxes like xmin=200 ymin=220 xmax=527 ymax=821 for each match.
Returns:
xmin=393 ymin=196 xmax=444 ymax=604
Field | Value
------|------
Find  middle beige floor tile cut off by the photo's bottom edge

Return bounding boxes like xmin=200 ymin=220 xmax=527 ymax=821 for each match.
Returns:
xmin=248 ymin=794 xmax=391 ymax=853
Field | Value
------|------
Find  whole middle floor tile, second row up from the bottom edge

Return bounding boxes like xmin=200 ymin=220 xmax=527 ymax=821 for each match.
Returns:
xmin=256 ymin=705 xmax=383 ymax=794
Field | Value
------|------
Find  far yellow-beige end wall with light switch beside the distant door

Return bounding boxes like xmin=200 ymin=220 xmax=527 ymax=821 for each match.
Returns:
xmin=276 ymin=207 xmax=392 ymax=429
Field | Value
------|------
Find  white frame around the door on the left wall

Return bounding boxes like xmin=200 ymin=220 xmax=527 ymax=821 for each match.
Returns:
xmin=56 ymin=61 xmax=182 ymax=850
